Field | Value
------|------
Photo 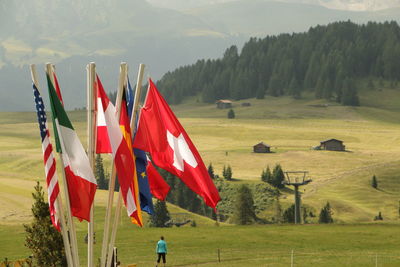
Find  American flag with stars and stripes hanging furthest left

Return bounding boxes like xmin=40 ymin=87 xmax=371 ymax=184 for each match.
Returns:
xmin=33 ymin=84 xmax=60 ymax=231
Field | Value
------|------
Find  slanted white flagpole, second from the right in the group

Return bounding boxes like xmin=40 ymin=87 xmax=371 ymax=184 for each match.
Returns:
xmin=100 ymin=62 xmax=128 ymax=267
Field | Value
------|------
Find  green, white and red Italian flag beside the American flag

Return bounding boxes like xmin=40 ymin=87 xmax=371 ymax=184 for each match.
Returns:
xmin=47 ymin=75 xmax=97 ymax=222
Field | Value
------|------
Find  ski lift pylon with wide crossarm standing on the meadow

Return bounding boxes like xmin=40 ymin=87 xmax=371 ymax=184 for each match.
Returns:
xmin=282 ymin=171 xmax=312 ymax=224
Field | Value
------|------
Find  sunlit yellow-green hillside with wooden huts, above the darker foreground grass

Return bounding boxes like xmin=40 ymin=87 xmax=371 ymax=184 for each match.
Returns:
xmin=0 ymin=85 xmax=400 ymax=223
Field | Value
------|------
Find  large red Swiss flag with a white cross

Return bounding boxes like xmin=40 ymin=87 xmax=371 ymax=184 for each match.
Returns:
xmin=133 ymin=80 xmax=220 ymax=209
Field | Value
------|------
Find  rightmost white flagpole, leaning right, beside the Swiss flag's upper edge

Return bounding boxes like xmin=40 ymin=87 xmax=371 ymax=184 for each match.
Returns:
xmin=106 ymin=64 xmax=145 ymax=267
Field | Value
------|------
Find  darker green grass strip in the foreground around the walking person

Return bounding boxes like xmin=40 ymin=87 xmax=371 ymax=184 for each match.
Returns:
xmin=0 ymin=223 xmax=400 ymax=266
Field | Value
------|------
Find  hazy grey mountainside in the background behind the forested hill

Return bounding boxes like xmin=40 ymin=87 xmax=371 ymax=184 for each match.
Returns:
xmin=0 ymin=0 xmax=400 ymax=111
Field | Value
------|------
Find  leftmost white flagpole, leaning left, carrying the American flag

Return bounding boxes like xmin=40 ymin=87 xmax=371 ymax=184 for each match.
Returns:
xmin=30 ymin=64 xmax=73 ymax=266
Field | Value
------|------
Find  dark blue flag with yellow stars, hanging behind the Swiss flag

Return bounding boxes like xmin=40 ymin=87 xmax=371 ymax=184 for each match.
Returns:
xmin=126 ymin=78 xmax=154 ymax=214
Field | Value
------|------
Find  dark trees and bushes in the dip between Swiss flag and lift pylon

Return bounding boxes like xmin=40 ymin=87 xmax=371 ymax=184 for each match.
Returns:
xmin=95 ymin=155 xmax=334 ymax=227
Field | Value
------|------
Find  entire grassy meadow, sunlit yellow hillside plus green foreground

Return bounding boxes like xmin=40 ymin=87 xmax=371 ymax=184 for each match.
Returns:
xmin=0 ymin=88 xmax=400 ymax=266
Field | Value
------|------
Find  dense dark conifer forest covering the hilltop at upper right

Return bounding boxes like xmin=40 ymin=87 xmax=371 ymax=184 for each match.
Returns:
xmin=157 ymin=21 xmax=400 ymax=105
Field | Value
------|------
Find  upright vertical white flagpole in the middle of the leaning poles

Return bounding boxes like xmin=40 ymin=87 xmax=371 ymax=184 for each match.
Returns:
xmin=86 ymin=62 xmax=97 ymax=267
